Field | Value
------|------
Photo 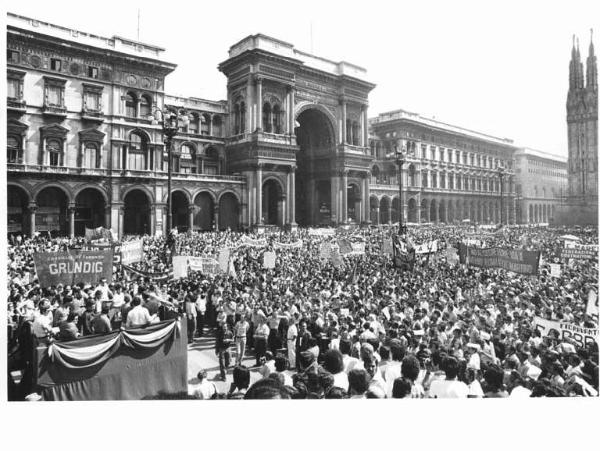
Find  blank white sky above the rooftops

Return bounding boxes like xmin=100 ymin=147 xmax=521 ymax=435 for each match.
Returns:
xmin=9 ymin=0 xmax=600 ymax=156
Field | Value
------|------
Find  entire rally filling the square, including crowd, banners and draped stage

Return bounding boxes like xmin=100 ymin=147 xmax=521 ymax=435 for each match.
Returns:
xmin=7 ymin=222 xmax=598 ymax=401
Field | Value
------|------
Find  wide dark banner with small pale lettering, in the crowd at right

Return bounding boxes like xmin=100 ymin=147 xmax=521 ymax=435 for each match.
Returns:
xmin=467 ymin=246 xmax=540 ymax=275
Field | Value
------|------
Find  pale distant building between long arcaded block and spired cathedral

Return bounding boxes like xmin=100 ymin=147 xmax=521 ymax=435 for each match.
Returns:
xmin=515 ymin=148 xmax=567 ymax=224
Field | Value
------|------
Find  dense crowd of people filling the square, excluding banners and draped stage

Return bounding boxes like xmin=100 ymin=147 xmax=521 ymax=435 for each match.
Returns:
xmin=8 ymin=225 xmax=598 ymax=399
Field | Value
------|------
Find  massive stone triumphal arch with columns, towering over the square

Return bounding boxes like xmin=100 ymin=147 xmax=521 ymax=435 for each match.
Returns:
xmin=219 ymin=34 xmax=375 ymax=228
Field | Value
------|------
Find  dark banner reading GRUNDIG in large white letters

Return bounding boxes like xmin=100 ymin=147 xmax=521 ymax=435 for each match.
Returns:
xmin=33 ymin=250 xmax=113 ymax=287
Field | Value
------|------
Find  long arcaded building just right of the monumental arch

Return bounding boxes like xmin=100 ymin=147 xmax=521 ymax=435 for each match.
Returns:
xmin=369 ymin=110 xmax=517 ymax=224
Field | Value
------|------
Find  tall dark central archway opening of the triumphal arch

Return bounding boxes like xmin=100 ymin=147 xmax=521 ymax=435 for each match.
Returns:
xmin=296 ymin=108 xmax=341 ymax=226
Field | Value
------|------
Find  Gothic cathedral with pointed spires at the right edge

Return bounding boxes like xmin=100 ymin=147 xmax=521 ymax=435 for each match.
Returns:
xmin=556 ymin=30 xmax=598 ymax=224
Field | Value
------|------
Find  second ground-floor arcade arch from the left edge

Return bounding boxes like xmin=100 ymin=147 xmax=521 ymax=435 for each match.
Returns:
xmin=35 ymin=187 xmax=69 ymax=236
